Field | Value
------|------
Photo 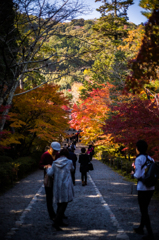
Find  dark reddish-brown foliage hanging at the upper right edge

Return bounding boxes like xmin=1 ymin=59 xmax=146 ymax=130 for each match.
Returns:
xmin=126 ymin=9 xmax=159 ymax=92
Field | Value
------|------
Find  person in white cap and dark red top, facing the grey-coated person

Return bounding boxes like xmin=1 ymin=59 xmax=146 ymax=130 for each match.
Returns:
xmin=39 ymin=142 xmax=61 ymax=220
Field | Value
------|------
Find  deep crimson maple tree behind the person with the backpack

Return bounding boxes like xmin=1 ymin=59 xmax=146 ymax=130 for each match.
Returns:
xmin=103 ymin=96 xmax=159 ymax=159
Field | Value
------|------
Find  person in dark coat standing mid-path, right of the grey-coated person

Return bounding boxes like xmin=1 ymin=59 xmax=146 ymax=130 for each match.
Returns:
xmin=79 ymin=147 xmax=90 ymax=186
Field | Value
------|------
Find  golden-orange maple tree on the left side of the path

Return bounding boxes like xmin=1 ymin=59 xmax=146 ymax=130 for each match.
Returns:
xmin=3 ymin=84 xmax=68 ymax=155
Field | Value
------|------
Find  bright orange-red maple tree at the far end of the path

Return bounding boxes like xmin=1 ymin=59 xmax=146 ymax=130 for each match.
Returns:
xmin=70 ymin=84 xmax=111 ymax=144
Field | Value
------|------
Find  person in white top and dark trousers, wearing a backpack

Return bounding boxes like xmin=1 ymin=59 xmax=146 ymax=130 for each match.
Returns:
xmin=134 ymin=140 xmax=155 ymax=240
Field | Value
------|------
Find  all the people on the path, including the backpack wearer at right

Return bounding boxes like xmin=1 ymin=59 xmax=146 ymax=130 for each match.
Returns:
xmin=40 ymin=140 xmax=155 ymax=240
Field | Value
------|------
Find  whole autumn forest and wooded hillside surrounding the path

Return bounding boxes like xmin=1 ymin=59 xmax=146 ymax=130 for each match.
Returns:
xmin=0 ymin=0 xmax=159 ymax=193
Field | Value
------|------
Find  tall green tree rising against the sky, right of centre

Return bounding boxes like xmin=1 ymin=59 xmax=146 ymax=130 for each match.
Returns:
xmin=78 ymin=0 xmax=135 ymax=96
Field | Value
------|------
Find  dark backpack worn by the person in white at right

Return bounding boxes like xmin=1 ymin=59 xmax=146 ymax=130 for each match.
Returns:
xmin=139 ymin=156 xmax=159 ymax=187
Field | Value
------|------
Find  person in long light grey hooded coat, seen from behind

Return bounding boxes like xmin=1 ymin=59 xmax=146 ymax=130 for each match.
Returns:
xmin=47 ymin=149 xmax=74 ymax=231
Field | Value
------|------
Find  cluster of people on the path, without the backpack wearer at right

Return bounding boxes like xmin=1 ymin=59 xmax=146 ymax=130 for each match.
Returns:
xmin=39 ymin=142 xmax=94 ymax=231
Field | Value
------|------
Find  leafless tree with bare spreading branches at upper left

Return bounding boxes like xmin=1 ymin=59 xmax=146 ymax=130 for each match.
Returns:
xmin=0 ymin=0 xmax=87 ymax=130
